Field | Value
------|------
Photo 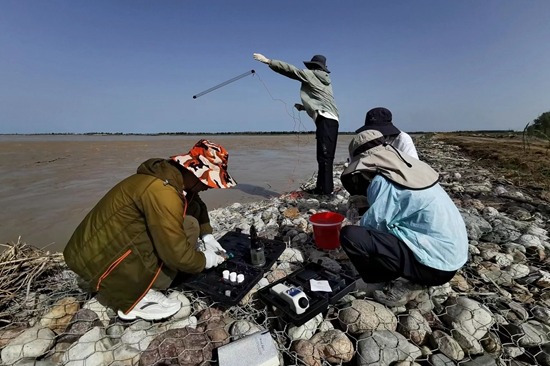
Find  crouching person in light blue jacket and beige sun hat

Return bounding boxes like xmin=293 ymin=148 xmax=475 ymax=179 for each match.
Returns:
xmin=340 ymin=130 xmax=468 ymax=294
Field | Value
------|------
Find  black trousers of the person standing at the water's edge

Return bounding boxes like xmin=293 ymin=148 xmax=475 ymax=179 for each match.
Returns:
xmin=315 ymin=115 xmax=338 ymax=194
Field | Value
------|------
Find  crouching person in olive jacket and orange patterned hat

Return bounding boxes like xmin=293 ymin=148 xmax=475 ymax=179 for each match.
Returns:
xmin=63 ymin=140 xmax=236 ymax=320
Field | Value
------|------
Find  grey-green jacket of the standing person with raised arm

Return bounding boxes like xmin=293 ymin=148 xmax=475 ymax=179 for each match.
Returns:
xmin=269 ymin=60 xmax=338 ymax=120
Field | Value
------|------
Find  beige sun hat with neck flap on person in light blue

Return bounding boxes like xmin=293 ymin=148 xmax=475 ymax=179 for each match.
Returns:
xmin=342 ymin=130 xmax=439 ymax=189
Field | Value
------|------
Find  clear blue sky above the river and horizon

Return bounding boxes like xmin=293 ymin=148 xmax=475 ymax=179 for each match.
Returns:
xmin=0 ymin=0 xmax=550 ymax=133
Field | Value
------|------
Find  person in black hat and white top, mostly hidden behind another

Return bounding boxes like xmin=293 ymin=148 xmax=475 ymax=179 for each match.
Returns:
xmin=355 ymin=107 xmax=418 ymax=159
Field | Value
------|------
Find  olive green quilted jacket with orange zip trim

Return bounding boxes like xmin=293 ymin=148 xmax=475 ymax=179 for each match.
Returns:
xmin=63 ymin=159 xmax=212 ymax=312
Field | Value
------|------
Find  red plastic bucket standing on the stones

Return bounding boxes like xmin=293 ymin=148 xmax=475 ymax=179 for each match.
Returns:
xmin=309 ymin=211 xmax=345 ymax=249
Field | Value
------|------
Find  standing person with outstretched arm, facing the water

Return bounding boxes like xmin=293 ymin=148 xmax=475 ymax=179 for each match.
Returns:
xmin=253 ymin=53 xmax=338 ymax=195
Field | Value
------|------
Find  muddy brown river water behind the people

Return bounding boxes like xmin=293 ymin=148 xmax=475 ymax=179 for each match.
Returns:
xmin=0 ymin=134 xmax=353 ymax=251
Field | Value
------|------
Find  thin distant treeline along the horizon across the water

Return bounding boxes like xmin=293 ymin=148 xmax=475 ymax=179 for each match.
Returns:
xmin=0 ymin=130 xmax=518 ymax=136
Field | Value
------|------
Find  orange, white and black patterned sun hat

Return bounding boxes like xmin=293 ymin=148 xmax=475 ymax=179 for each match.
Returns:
xmin=170 ymin=139 xmax=237 ymax=188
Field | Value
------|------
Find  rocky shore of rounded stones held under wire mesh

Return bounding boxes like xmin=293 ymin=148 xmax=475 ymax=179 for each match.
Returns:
xmin=0 ymin=136 xmax=550 ymax=366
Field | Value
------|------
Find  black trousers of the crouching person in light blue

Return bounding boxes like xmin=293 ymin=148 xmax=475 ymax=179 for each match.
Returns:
xmin=340 ymin=225 xmax=456 ymax=286
